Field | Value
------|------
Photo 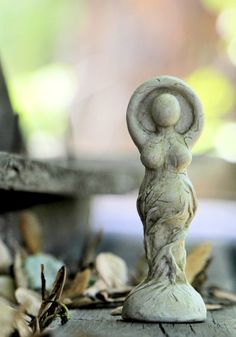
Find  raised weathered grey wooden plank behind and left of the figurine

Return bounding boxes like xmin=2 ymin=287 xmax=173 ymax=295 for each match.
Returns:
xmin=0 ymin=152 xmax=140 ymax=197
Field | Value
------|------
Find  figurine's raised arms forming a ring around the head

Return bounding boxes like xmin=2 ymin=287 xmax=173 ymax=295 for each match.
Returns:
xmin=127 ymin=76 xmax=203 ymax=146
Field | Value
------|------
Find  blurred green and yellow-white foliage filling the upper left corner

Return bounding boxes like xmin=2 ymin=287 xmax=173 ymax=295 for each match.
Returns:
xmin=0 ymin=0 xmax=86 ymax=155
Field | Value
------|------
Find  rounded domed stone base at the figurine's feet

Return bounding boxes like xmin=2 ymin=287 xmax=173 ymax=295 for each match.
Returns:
xmin=122 ymin=280 xmax=206 ymax=323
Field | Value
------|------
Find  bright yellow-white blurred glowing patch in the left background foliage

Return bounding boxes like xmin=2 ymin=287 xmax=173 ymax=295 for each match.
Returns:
xmin=11 ymin=63 xmax=77 ymax=137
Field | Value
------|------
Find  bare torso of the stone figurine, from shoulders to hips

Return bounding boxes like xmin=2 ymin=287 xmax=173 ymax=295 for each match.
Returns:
xmin=139 ymin=130 xmax=194 ymax=209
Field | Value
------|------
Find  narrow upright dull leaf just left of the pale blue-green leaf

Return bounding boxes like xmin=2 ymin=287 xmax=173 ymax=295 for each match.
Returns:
xmin=13 ymin=249 xmax=28 ymax=288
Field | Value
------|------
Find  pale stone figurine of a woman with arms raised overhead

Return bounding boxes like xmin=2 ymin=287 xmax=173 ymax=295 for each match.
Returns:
xmin=122 ymin=76 xmax=206 ymax=322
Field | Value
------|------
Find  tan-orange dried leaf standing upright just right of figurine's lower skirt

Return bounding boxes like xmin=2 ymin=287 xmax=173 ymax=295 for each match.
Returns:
xmin=185 ymin=243 xmax=212 ymax=283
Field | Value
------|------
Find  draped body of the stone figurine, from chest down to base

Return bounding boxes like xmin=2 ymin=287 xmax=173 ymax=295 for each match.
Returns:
xmin=137 ymin=131 xmax=196 ymax=283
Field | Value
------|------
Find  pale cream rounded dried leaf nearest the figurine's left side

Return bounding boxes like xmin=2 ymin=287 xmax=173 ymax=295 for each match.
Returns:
xmin=96 ymin=253 xmax=128 ymax=288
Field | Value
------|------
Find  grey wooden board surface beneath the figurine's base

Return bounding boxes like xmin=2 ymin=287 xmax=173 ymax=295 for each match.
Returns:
xmin=53 ymin=307 xmax=236 ymax=337
